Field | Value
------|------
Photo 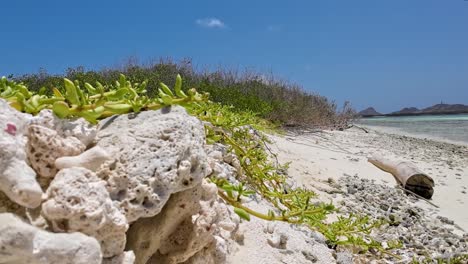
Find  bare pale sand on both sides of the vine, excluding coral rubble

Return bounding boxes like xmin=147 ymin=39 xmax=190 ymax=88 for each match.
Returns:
xmin=228 ymin=129 xmax=468 ymax=264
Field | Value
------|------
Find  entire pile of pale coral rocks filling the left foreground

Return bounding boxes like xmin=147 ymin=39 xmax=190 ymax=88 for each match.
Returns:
xmin=0 ymin=100 xmax=249 ymax=264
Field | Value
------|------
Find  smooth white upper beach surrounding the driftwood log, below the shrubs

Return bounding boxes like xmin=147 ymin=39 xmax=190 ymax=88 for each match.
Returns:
xmin=266 ymin=128 xmax=468 ymax=232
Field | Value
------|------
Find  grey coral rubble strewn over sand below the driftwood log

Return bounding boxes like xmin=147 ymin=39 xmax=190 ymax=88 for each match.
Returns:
xmin=339 ymin=176 xmax=468 ymax=263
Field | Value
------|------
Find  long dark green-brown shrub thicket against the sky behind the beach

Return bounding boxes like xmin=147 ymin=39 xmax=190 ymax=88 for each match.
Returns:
xmin=14 ymin=58 xmax=355 ymax=129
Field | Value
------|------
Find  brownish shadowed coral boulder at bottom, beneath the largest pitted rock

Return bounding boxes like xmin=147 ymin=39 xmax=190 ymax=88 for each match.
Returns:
xmin=127 ymin=181 xmax=239 ymax=263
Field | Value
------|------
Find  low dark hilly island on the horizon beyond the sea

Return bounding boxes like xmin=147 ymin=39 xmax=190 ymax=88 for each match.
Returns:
xmin=359 ymin=103 xmax=468 ymax=117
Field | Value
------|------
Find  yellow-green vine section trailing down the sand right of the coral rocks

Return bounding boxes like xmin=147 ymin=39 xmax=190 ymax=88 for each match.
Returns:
xmin=192 ymin=100 xmax=401 ymax=258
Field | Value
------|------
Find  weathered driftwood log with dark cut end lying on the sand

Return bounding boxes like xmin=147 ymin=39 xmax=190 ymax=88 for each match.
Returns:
xmin=368 ymin=155 xmax=434 ymax=199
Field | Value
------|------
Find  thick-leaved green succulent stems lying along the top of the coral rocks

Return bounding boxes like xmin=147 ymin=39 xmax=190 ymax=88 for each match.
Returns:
xmin=0 ymin=74 xmax=208 ymax=124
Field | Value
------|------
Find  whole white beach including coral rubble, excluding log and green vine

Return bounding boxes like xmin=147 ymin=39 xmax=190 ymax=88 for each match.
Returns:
xmin=229 ymin=128 xmax=468 ymax=264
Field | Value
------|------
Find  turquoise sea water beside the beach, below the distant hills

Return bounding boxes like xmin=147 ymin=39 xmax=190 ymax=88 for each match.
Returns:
xmin=356 ymin=114 xmax=468 ymax=144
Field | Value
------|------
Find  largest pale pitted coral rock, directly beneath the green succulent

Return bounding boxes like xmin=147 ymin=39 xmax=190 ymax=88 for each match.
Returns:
xmin=97 ymin=107 xmax=211 ymax=223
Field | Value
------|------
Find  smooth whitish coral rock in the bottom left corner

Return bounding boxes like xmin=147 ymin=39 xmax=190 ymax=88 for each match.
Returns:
xmin=0 ymin=213 xmax=102 ymax=264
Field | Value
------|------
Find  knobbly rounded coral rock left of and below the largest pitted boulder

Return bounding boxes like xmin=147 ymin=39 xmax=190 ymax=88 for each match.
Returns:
xmin=42 ymin=167 xmax=128 ymax=257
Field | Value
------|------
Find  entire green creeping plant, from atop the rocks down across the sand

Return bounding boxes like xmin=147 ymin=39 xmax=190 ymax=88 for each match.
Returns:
xmin=0 ymin=75 xmax=401 ymax=254
